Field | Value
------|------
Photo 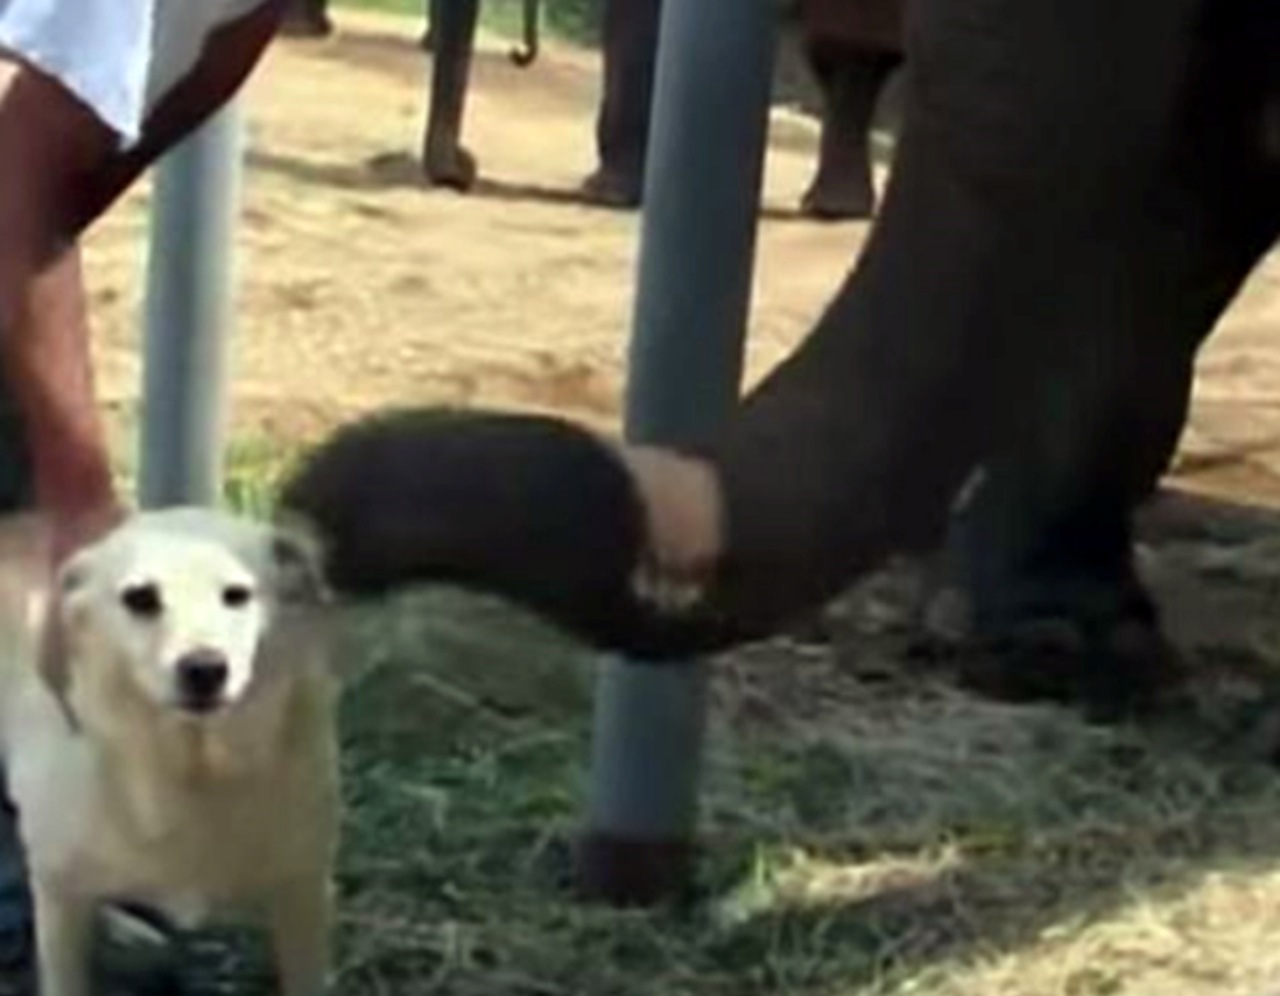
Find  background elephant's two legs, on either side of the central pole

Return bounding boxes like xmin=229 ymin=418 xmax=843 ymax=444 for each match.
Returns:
xmin=582 ymin=0 xmax=904 ymax=220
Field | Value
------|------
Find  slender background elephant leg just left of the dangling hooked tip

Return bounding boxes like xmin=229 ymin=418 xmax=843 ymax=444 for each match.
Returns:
xmin=422 ymin=0 xmax=480 ymax=191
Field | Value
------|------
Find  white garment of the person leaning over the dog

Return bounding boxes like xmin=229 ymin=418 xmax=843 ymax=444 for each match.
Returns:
xmin=0 ymin=0 xmax=266 ymax=146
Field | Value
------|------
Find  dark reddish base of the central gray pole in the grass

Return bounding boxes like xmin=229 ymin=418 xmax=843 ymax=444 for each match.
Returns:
xmin=573 ymin=831 xmax=696 ymax=906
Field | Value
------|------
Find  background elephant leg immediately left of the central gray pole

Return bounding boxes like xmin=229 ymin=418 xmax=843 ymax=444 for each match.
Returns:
xmin=582 ymin=0 xmax=662 ymax=207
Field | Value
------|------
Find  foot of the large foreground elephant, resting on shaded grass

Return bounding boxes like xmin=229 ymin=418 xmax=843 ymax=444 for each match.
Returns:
xmin=918 ymin=578 xmax=1189 ymax=722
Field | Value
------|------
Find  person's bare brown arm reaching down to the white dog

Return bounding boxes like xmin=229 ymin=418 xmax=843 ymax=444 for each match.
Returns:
xmin=0 ymin=0 xmax=280 ymax=556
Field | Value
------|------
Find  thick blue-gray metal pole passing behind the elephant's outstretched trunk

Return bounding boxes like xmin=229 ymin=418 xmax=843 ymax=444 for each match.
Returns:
xmin=577 ymin=0 xmax=778 ymax=904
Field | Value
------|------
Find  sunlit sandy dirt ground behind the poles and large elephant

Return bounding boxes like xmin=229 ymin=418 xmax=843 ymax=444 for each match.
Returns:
xmin=82 ymin=12 xmax=1280 ymax=501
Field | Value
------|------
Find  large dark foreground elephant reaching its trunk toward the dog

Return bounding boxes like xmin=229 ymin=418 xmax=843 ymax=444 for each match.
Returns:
xmin=279 ymin=0 xmax=1280 ymax=714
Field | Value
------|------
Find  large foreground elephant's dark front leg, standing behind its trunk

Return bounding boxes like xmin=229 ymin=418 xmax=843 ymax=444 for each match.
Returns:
xmin=931 ymin=1 xmax=1280 ymax=708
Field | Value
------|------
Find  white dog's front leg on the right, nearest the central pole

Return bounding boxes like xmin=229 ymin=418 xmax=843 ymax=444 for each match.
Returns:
xmin=268 ymin=874 xmax=333 ymax=996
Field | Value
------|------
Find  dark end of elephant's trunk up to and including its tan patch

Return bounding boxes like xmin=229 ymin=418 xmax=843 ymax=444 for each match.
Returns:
xmin=280 ymin=411 xmax=742 ymax=659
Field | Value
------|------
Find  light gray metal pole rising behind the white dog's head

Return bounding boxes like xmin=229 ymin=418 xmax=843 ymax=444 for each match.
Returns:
xmin=138 ymin=101 xmax=242 ymax=507
